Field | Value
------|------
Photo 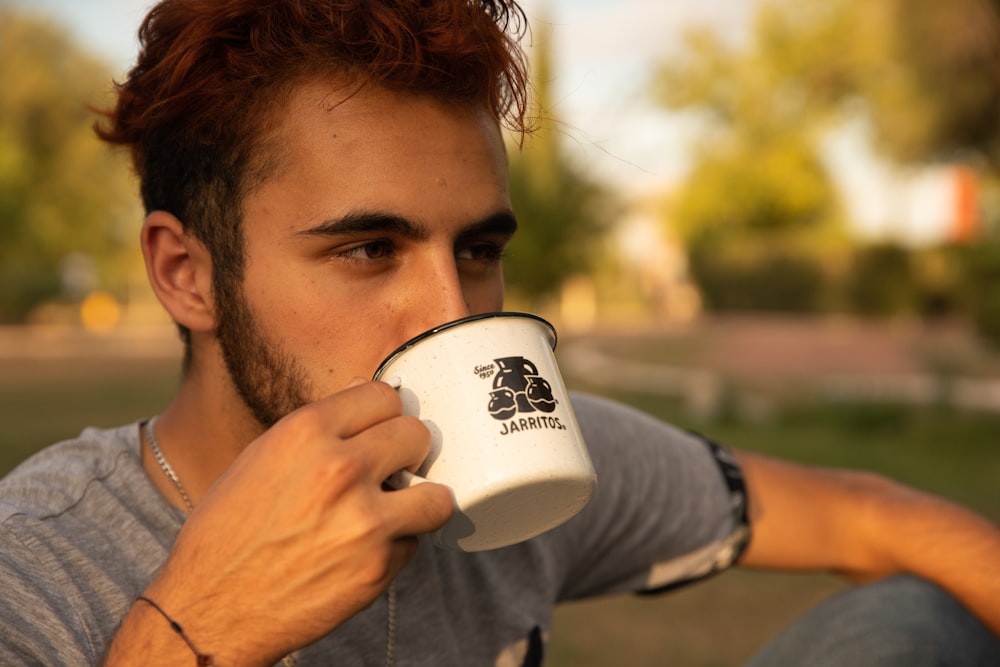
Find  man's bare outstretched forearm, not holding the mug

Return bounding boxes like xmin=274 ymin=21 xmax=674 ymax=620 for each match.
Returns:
xmin=736 ymin=452 xmax=1000 ymax=635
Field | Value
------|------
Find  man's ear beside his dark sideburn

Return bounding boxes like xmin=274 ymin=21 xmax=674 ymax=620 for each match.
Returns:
xmin=141 ymin=211 xmax=215 ymax=332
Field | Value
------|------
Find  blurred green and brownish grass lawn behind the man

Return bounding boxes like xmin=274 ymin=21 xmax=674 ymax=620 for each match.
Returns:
xmin=0 ymin=350 xmax=1000 ymax=667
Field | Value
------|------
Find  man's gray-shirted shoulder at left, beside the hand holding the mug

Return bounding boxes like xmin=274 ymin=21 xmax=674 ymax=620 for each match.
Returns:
xmin=0 ymin=424 xmax=158 ymax=664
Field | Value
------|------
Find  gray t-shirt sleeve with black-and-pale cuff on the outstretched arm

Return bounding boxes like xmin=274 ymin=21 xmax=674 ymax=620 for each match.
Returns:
xmin=550 ymin=394 xmax=750 ymax=600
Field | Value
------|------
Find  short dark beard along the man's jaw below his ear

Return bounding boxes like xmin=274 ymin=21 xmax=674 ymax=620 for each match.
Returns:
xmin=216 ymin=284 xmax=312 ymax=429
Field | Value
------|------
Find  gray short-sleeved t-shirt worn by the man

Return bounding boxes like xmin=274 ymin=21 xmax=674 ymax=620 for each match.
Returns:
xmin=0 ymin=395 xmax=748 ymax=667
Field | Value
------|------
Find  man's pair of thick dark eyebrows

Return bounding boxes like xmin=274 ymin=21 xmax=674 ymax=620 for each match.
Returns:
xmin=295 ymin=210 xmax=517 ymax=241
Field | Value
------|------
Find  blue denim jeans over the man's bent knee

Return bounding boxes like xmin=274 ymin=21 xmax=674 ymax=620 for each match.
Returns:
xmin=746 ymin=575 xmax=1000 ymax=667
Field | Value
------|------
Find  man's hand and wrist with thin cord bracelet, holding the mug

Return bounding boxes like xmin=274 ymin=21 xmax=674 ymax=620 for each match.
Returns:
xmin=107 ymin=382 xmax=453 ymax=667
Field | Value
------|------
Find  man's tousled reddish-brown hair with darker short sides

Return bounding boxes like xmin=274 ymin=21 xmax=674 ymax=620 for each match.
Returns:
xmin=95 ymin=0 xmax=528 ymax=362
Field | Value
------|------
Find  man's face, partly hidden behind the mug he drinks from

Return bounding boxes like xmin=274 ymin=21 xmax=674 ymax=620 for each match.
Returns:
xmin=218 ymin=83 xmax=515 ymax=426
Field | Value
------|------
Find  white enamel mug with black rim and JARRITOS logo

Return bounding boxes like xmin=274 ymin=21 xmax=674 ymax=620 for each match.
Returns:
xmin=374 ymin=312 xmax=597 ymax=551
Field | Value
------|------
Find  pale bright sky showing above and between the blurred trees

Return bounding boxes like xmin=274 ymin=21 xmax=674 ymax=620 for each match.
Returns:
xmin=9 ymin=0 xmax=758 ymax=190
